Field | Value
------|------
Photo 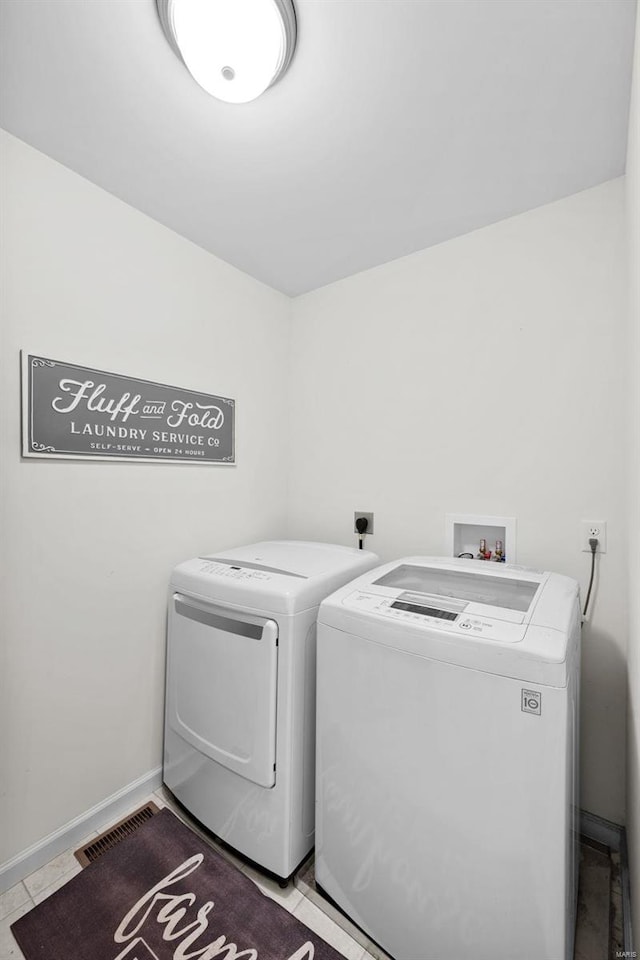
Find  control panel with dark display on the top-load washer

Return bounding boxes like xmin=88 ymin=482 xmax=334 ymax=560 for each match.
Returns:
xmin=343 ymin=590 xmax=526 ymax=643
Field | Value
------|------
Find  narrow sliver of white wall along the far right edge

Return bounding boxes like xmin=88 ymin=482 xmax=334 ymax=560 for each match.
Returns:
xmin=626 ymin=3 xmax=640 ymax=950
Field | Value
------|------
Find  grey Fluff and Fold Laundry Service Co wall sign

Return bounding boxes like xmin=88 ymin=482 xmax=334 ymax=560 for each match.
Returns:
xmin=22 ymin=351 xmax=235 ymax=464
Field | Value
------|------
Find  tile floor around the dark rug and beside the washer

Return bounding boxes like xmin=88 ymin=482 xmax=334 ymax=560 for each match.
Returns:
xmin=0 ymin=788 xmax=621 ymax=960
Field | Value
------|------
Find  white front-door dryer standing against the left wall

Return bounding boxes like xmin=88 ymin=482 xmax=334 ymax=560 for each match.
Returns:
xmin=164 ymin=541 xmax=378 ymax=878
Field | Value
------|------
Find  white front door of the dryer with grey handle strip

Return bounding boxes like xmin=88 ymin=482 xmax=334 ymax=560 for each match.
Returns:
xmin=167 ymin=593 xmax=278 ymax=787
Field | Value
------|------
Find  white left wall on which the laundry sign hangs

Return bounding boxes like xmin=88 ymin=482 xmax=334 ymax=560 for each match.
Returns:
xmin=0 ymin=134 xmax=290 ymax=864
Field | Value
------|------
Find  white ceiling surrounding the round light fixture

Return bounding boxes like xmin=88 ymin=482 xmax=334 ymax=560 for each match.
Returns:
xmin=0 ymin=0 xmax=636 ymax=295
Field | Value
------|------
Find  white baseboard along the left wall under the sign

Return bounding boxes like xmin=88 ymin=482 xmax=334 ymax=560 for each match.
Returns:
xmin=0 ymin=767 xmax=162 ymax=893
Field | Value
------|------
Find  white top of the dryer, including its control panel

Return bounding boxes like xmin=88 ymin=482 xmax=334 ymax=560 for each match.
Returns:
xmin=171 ymin=540 xmax=379 ymax=614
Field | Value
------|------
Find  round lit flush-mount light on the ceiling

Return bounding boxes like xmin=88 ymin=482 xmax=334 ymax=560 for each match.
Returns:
xmin=156 ymin=0 xmax=296 ymax=103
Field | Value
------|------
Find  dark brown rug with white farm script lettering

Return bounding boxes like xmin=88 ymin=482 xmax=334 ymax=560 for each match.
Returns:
xmin=11 ymin=810 xmax=341 ymax=960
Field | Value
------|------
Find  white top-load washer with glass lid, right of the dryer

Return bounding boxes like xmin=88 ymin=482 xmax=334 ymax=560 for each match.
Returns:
xmin=316 ymin=557 xmax=581 ymax=960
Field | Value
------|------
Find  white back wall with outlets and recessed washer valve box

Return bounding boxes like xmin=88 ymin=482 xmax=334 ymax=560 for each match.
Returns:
xmin=290 ymin=181 xmax=626 ymax=822
